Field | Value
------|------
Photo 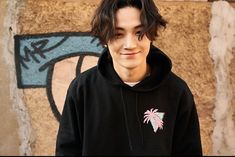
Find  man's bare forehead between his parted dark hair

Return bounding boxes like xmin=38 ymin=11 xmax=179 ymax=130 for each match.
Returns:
xmin=116 ymin=7 xmax=141 ymax=29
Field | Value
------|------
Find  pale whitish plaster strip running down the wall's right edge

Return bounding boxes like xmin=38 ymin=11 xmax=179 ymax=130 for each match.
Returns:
xmin=209 ymin=1 xmax=235 ymax=155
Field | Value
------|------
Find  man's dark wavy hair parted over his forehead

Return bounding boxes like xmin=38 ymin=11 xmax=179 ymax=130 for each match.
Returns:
xmin=91 ymin=0 xmax=167 ymax=45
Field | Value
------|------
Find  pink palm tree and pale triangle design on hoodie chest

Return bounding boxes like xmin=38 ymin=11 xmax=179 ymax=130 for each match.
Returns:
xmin=144 ymin=108 xmax=164 ymax=132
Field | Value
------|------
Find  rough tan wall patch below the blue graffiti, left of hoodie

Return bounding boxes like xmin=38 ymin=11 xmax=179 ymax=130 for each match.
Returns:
xmin=24 ymin=88 xmax=58 ymax=156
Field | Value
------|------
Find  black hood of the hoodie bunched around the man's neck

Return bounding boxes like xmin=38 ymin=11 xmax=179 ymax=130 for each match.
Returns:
xmin=98 ymin=45 xmax=172 ymax=92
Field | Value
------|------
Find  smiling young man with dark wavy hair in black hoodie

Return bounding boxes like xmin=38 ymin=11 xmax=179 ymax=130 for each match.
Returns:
xmin=56 ymin=0 xmax=202 ymax=155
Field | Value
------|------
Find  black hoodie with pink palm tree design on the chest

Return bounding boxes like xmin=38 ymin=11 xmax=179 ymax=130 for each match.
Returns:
xmin=56 ymin=45 xmax=202 ymax=155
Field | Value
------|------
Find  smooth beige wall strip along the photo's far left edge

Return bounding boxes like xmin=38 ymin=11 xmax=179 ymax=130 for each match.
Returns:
xmin=0 ymin=0 xmax=20 ymax=156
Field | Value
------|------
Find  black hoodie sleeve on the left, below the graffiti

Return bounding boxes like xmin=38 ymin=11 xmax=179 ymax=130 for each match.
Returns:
xmin=55 ymin=80 xmax=82 ymax=156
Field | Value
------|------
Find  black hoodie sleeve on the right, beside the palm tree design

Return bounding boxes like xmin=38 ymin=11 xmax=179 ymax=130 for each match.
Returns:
xmin=172 ymin=85 xmax=202 ymax=156
